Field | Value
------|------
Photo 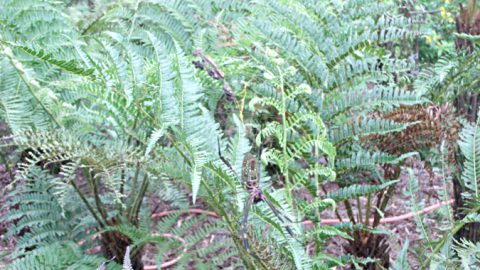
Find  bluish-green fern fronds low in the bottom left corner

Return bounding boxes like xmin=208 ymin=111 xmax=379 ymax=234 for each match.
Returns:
xmin=3 ymin=167 xmax=119 ymax=269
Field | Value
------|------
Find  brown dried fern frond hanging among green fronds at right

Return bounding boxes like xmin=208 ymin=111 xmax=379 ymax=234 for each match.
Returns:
xmin=362 ymin=104 xmax=461 ymax=158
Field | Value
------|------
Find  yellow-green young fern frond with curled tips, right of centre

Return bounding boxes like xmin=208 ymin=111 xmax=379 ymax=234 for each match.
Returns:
xmin=251 ymin=69 xmax=336 ymax=194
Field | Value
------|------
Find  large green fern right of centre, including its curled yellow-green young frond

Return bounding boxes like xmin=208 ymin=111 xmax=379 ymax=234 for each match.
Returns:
xmin=218 ymin=0 xmax=427 ymax=266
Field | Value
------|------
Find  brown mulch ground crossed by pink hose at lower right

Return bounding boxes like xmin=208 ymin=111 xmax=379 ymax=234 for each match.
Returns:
xmin=324 ymin=158 xmax=453 ymax=270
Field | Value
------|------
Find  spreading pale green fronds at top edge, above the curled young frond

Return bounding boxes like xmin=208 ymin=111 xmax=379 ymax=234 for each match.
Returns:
xmin=236 ymin=1 xmax=414 ymax=91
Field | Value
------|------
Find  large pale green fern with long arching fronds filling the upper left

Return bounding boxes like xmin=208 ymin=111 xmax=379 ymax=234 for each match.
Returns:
xmin=0 ymin=1 xmax=248 ymax=268
